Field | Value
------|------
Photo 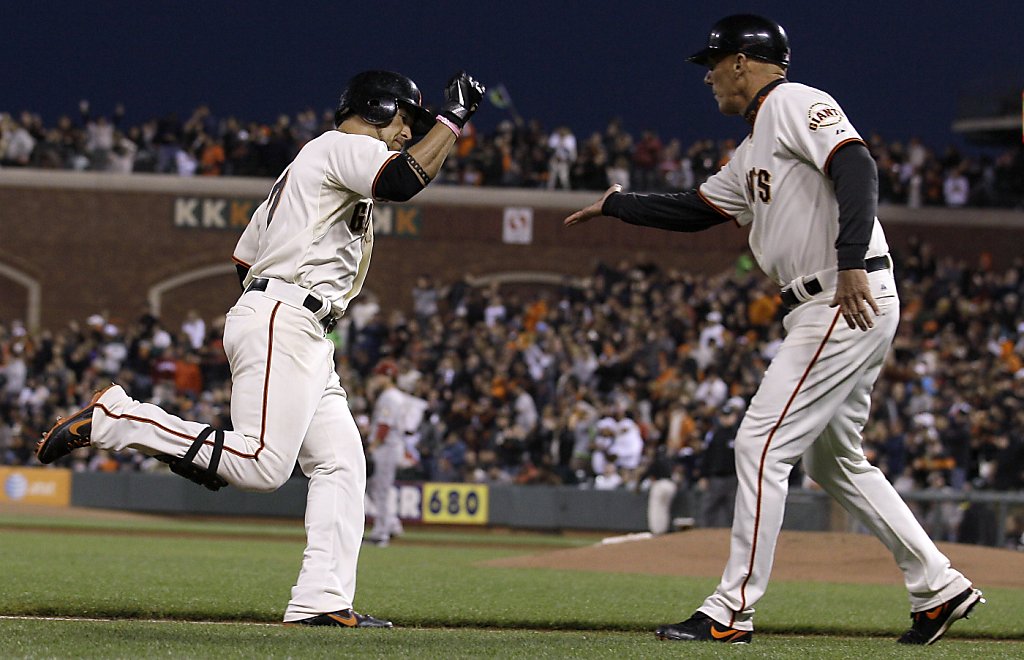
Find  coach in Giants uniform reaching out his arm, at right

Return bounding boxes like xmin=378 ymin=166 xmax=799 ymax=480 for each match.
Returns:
xmin=565 ymin=15 xmax=984 ymax=644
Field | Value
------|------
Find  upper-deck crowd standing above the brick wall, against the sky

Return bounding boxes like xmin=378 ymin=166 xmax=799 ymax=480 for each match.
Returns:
xmin=0 ymin=101 xmax=1024 ymax=209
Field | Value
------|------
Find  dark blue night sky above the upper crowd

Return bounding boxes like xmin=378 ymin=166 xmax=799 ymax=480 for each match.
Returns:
xmin=8 ymin=0 xmax=1024 ymax=147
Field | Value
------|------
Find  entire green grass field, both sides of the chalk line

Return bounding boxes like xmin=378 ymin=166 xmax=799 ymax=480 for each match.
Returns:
xmin=0 ymin=517 xmax=1024 ymax=658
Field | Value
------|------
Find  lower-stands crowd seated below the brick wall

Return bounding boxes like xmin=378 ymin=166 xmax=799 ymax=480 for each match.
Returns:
xmin=0 ymin=236 xmax=1024 ymax=544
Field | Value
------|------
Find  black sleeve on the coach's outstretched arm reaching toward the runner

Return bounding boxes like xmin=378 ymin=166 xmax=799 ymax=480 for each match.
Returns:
xmin=601 ymin=190 xmax=729 ymax=231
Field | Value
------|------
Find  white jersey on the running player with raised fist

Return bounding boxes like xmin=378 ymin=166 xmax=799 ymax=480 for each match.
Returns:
xmin=233 ymin=131 xmax=398 ymax=316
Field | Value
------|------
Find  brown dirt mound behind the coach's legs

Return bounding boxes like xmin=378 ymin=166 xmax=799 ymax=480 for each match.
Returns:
xmin=485 ymin=529 xmax=1024 ymax=588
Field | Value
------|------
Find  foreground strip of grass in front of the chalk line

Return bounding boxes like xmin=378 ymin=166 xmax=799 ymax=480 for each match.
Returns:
xmin=0 ymin=620 xmax=1021 ymax=660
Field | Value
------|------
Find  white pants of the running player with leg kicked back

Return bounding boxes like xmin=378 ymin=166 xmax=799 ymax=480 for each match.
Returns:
xmin=92 ymin=292 xmax=367 ymax=621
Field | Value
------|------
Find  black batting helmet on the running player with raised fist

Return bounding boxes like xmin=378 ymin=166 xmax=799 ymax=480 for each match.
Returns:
xmin=334 ymin=71 xmax=434 ymax=135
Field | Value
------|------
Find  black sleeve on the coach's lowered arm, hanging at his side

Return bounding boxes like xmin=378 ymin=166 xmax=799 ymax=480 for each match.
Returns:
xmin=825 ymin=142 xmax=879 ymax=270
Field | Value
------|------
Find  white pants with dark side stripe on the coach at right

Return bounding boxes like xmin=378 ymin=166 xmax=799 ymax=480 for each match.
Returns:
xmin=698 ymin=269 xmax=970 ymax=630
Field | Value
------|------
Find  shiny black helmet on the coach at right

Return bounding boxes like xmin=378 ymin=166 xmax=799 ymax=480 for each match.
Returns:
xmin=686 ymin=13 xmax=790 ymax=68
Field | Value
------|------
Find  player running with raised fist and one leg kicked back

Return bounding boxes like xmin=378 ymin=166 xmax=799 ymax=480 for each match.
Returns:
xmin=36 ymin=71 xmax=484 ymax=627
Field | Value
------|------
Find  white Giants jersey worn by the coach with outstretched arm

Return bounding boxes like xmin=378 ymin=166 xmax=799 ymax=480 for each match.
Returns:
xmin=699 ymin=82 xmax=889 ymax=287
